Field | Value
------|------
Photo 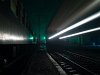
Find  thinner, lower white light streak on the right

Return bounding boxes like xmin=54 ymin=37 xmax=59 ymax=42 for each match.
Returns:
xmin=59 ymin=27 xmax=100 ymax=39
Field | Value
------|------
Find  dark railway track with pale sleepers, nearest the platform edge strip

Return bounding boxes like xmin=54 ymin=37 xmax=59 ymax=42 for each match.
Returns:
xmin=50 ymin=53 xmax=99 ymax=75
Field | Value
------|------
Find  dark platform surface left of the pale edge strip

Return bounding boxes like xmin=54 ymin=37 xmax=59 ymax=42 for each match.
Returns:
xmin=23 ymin=52 xmax=60 ymax=75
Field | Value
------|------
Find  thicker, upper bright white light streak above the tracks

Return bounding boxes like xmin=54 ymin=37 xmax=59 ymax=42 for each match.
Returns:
xmin=48 ymin=11 xmax=100 ymax=39
